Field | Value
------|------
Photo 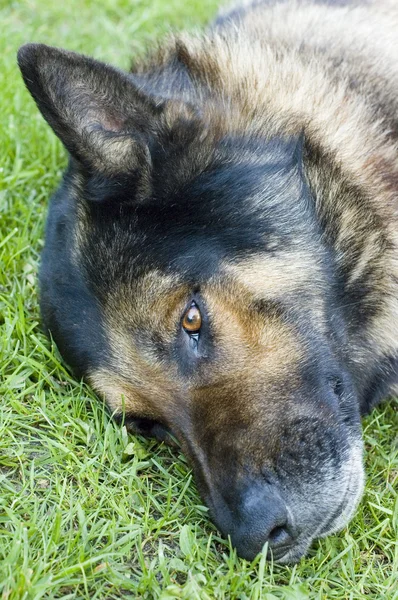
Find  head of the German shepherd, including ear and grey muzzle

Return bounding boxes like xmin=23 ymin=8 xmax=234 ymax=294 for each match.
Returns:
xmin=19 ymin=45 xmax=363 ymax=562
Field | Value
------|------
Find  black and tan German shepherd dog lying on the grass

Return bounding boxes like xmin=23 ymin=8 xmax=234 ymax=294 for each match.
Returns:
xmin=18 ymin=0 xmax=398 ymax=563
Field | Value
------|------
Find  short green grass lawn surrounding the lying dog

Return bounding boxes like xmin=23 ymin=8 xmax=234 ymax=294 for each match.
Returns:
xmin=0 ymin=0 xmax=398 ymax=600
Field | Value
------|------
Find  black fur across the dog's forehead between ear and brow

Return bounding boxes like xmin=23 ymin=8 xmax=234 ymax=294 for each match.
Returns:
xmin=80 ymin=149 xmax=315 ymax=290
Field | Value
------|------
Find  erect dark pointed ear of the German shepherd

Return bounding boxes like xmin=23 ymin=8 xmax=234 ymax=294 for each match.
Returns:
xmin=18 ymin=44 xmax=162 ymax=179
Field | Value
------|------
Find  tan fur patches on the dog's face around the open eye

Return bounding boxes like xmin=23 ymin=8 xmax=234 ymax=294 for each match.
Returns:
xmin=88 ymin=270 xmax=303 ymax=422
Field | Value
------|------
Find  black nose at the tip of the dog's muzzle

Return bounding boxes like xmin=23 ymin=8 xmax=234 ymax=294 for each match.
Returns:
xmin=224 ymin=483 xmax=294 ymax=560
